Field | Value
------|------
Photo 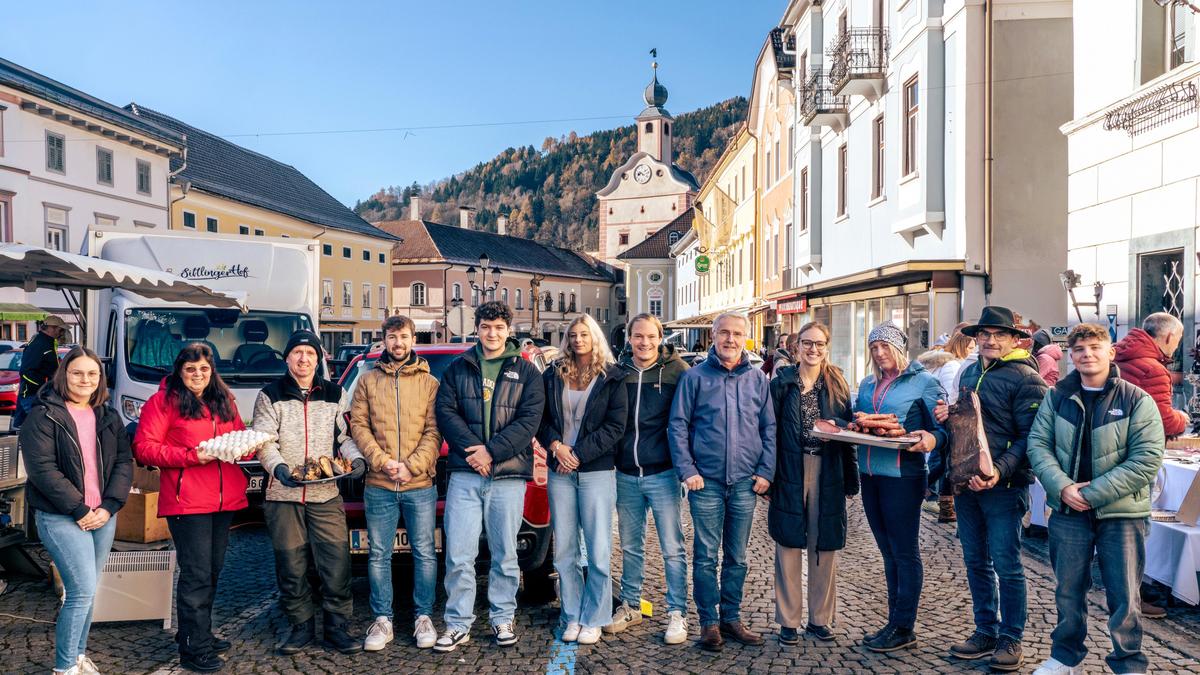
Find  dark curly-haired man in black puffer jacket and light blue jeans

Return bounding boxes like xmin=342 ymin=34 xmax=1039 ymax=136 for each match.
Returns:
xmin=433 ymin=301 xmax=546 ymax=652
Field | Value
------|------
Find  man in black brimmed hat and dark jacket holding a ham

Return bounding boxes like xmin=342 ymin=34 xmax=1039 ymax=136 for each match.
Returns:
xmin=934 ymin=306 xmax=1046 ymax=670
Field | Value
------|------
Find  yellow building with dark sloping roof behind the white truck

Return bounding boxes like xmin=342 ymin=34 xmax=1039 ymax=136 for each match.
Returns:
xmin=128 ymin=103 xmax=400 ymax=353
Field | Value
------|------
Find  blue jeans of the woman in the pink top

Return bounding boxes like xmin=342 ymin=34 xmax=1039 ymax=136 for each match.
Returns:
xmin=37 ymin=510 xmax=116 ymax=670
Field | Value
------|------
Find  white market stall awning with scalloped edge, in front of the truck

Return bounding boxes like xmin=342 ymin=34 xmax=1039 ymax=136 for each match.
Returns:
xmin=0 ymin=244 xmax=241 ymax=309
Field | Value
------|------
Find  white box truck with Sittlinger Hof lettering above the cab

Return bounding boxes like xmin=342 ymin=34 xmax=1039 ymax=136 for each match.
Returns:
xmin=83 ymin=231 xmax=320 ymax=424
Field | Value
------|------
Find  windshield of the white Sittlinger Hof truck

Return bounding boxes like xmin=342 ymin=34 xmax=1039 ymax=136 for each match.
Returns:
xmin=125 ymin=307 xmax=312 ymax=382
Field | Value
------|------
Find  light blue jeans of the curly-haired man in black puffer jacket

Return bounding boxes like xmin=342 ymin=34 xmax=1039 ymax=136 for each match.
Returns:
xmin=444 ymin=471 xmax=526 ymax=631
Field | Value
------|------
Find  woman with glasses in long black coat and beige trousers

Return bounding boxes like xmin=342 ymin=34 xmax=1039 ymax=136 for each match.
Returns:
xmin=767 ymin=323 xmax=858 ymax=645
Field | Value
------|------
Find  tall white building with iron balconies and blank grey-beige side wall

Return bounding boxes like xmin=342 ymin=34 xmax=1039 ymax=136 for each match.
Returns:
xmin=767 ymin=0 xmax=1073 ymax=381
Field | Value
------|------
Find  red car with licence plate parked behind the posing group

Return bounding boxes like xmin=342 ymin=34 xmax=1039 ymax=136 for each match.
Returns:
xmin=340 ymin=342 xmax=553 ymax=598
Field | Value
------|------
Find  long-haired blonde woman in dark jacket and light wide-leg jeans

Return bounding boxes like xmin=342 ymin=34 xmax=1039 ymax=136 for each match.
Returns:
xmin=538 ymin=315 xmax=628 ymax=645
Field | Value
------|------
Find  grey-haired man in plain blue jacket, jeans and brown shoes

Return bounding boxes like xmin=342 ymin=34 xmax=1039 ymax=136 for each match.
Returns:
xmin=667 ymin=312 xmax=775 ymax=651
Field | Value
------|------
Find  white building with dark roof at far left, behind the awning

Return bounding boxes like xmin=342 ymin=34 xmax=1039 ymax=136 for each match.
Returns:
xmin=0 ymin=59 xmax=184 ymax=340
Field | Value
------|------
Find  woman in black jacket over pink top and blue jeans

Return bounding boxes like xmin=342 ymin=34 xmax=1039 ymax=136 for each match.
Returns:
xmin=19 ymin=347 xmax=133 ymax=673
